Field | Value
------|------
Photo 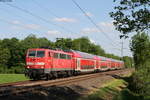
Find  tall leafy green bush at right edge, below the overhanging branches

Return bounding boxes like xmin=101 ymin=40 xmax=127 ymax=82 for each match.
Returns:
xmin=129 ymin=33 xmax=150 ymax=97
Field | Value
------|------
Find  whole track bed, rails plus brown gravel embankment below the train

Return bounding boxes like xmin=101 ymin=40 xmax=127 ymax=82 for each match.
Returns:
xmin=0 ymin=69 xmax=130 ymax=100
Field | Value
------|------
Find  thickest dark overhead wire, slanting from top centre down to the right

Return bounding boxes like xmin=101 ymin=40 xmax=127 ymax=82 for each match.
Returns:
xmin=72 ymin=0 xmax=121 ymax=46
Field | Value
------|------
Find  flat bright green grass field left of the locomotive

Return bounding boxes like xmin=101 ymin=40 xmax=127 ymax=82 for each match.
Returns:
xmin=0 ymin=74 xmax=29 ymax=84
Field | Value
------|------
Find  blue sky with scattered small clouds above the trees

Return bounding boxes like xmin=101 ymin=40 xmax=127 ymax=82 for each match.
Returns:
xmin=0 ymin=0 xmax=131 ymax=56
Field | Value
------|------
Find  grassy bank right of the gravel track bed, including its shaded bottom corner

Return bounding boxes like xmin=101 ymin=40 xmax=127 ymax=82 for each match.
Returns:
xmin=79 ymin=70 xmax=150 ymax=100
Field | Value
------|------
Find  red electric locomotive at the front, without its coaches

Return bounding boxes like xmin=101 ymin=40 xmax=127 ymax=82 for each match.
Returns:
xmin=25 ymin=48 xmax=74 ymax=79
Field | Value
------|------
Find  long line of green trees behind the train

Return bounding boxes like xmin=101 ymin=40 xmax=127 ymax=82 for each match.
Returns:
xmin=0 ymin=34 xmax=132 ymax=73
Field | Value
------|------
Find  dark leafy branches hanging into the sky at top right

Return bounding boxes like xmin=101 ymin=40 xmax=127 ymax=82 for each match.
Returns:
xmin=110 ymin=0 xmax=150 ymax=37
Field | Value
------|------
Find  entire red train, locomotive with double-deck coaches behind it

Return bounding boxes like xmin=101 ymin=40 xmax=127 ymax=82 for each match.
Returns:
xmin=25 ymin=48 xmax=123 ymax=80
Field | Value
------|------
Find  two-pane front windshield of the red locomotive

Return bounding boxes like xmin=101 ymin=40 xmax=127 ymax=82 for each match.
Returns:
xmin=28 ymin=50 xmax=45 ymax=57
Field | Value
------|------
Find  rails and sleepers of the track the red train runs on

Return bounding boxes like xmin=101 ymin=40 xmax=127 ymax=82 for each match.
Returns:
xmin=0 ymin=69 xmax=127 ymax=96
